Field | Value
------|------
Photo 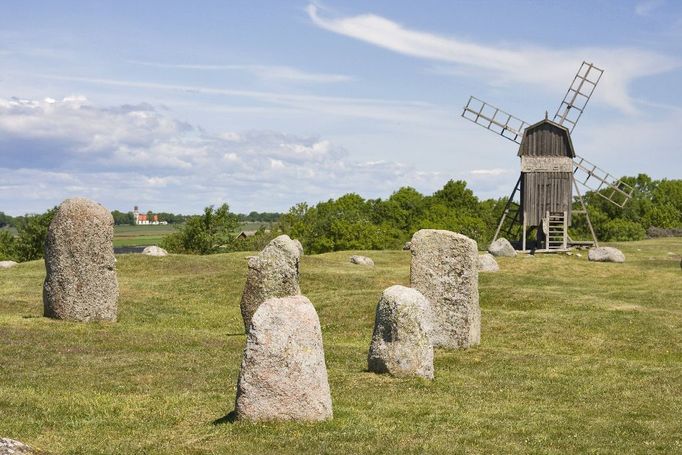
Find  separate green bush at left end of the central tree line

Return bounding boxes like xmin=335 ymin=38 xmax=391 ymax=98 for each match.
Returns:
xmin=161 ymin=204 xmax=238 ymax=254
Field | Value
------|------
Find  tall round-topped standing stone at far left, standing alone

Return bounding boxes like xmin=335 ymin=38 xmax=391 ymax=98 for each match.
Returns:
xmin=43 ymin=198 xmax=118 ymax=322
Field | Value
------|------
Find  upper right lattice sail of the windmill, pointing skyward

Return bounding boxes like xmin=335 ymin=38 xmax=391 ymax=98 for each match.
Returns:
xmin=554 ymin=62 xmax=604 ymax=133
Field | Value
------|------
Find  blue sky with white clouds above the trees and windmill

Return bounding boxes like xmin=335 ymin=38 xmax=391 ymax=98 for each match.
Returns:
xmin=0 ymin=0 xmax=682 ymax=215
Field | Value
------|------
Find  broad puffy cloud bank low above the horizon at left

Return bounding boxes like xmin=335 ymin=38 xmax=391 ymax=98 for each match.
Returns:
xmin=0 ymin=98 xmax=447 ymax=214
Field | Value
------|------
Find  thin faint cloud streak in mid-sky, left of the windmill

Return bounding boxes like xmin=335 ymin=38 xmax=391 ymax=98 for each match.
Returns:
xmin=129 ymin=60 xmax=353 ymax=83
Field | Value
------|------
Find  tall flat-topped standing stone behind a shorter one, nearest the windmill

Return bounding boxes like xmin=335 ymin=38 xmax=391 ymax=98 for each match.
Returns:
xmin=410 ymin=229 xmax=481 ymax=348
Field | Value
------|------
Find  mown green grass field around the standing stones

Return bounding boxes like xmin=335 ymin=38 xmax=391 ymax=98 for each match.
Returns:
xmin=0 ymin=239 xmax=682 ymax=454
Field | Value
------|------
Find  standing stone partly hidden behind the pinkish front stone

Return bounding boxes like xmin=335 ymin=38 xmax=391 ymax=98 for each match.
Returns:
xmin=239 ymin=235 xmax=301 ymax=332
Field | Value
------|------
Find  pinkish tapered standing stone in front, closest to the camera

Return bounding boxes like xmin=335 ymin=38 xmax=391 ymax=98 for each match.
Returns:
xmin=235 ymin=295 xmax=332 ymax=421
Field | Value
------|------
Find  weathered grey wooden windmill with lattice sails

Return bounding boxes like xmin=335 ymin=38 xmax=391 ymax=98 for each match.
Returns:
xmin=462 ymin=62 xmax=633 ymax=251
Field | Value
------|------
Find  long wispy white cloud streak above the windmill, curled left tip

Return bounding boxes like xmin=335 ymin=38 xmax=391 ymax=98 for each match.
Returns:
xmin=307 ymin=4 xmax=681 ymax=113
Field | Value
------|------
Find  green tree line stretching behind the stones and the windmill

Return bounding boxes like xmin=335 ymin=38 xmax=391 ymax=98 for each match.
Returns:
xmin=0 ymin=174 xmax=682 ymax=261
